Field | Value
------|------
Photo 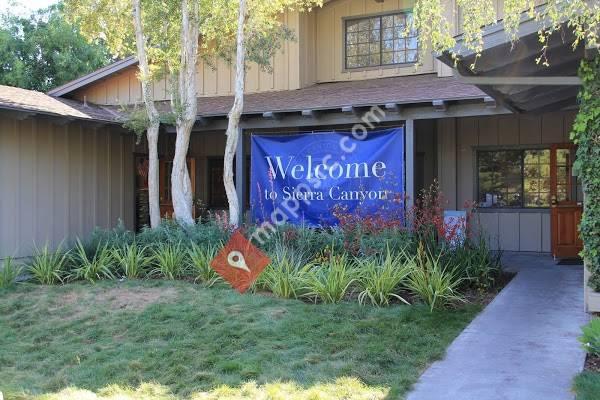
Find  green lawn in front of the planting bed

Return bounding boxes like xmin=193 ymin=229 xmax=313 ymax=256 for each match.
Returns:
xmin=0 ymin=280 xmax=480 ymax=400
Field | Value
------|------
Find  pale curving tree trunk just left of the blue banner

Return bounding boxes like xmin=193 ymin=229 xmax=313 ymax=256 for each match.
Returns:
xmin=223 ymin=0 xmax=247 ymax=227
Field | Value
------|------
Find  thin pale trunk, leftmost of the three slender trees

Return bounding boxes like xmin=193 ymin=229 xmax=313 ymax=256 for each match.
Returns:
xmin=132 ymin=0 xmax=160 ymax=228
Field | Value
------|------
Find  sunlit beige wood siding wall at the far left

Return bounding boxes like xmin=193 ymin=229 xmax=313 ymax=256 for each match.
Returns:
xmin=0 ymin=115 xmax=134 ymax=258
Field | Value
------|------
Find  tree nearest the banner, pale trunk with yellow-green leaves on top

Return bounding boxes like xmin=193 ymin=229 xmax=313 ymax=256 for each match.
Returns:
xmin=212 ymin=0 xmax=323 ymax=227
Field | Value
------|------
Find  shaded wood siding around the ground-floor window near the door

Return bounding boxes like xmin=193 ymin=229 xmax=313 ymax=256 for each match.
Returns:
xmin=437 ymin=112 xmax=575 ymax=252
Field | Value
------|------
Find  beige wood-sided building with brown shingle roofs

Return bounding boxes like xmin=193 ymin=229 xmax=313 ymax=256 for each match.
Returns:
xmin=0 ymin=0 xmax=584 ymax=258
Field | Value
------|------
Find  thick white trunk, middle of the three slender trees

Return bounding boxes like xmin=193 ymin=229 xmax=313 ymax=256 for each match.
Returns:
xmin=171 ymin=0 xmax=199 ymax=225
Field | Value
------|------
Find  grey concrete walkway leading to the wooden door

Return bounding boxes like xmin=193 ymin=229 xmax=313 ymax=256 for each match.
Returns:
xmin=408 ymin=253 xmax=588 ymax=400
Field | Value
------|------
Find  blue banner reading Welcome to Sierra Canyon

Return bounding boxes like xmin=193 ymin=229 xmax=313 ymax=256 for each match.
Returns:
xmin=250 ymin=128 xmax=404 ymax=226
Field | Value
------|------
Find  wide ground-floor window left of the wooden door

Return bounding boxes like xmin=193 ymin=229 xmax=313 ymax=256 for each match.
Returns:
xmin=477 ymin=149 xmax=550 ymax=208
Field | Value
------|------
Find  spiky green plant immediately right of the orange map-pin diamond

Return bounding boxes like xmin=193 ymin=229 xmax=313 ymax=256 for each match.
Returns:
xmin=258 ymin=247 xmax=310 ymax=299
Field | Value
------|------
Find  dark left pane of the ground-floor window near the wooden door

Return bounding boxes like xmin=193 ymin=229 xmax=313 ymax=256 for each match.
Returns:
xmin=477 ymin=150 xmax=522 ymax=207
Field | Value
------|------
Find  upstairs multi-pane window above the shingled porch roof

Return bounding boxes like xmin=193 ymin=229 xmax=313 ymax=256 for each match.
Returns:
xmin=345 ymin=13 xmax=418 ymax=69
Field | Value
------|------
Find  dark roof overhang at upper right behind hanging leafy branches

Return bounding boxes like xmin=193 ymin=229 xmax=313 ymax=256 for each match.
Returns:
xmin=438 ymin=5 xmax=586 ymax=113
